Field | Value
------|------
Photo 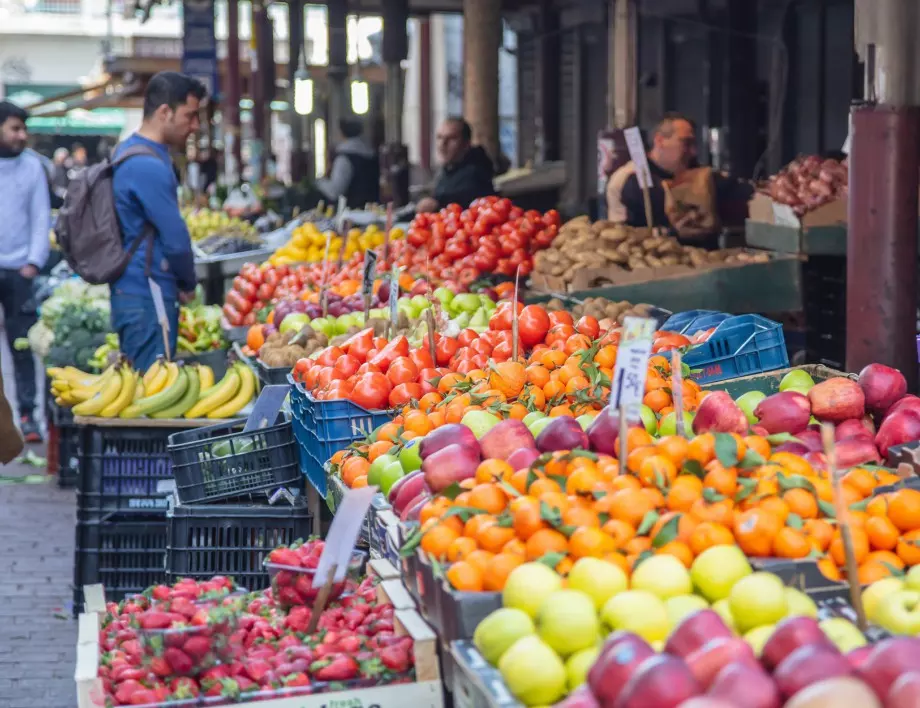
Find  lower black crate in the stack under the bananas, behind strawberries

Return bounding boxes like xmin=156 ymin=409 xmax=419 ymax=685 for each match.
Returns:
xmin=73 ymin=512 xmax=166 ymax=615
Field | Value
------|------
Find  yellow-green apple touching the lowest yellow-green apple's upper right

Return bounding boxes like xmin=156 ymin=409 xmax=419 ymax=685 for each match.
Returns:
xmin=534 ymin=590 xmax=601 ymax=658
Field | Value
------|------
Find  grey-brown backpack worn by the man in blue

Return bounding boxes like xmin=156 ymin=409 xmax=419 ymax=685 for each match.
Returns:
xmin=54 ymin=145 xmax=161 ymax=285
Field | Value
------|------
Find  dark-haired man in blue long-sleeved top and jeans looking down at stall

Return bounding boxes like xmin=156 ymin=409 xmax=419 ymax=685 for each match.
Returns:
xmin=111 ymin=71 xmax=205 ymax=370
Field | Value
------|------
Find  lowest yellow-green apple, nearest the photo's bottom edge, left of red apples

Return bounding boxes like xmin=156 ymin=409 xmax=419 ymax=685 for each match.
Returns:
xmin=498 ymin=635 xmax=568 ymax=706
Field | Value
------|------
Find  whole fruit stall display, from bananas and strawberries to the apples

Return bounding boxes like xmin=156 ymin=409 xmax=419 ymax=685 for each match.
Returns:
xmin=43 ymin=194 xmax=920 ymax=708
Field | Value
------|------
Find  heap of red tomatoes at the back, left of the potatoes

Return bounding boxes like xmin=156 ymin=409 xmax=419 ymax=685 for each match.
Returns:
xmin=399 ymin=197 xmax=559 ymax=286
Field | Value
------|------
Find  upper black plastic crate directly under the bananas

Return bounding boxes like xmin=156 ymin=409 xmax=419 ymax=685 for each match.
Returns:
xmin=77 ymin=427 xmax=173 ymax=513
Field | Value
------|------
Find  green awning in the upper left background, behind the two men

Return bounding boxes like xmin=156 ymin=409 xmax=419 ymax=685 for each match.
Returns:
xmin=5 ymin=84 xmax=133 ymax=136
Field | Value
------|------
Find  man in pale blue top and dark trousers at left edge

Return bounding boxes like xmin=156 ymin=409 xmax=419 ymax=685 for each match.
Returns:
xmin=0 ymin=101 xmax=51 ymax=442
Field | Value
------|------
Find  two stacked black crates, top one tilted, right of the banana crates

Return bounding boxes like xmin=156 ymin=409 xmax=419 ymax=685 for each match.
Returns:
xmin=166 ymin=422 xmax=313 ymax=589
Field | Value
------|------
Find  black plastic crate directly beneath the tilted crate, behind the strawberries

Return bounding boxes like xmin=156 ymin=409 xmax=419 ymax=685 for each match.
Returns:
xmin=166 ymin=498 xmax=313 ymax=590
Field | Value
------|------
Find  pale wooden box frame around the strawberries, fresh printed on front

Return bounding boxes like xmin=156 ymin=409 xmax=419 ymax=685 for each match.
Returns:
xmin=74 ymin=580 xmax=444 ymax=708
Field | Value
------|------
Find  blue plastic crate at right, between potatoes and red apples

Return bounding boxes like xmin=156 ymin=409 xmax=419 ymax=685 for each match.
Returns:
xmin=668 ymin=315 xmax=789 ymax=383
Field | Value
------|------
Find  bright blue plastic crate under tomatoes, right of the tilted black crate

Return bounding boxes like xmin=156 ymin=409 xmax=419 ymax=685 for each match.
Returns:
xmin=291 ymin=382 xmax=393 ymax=498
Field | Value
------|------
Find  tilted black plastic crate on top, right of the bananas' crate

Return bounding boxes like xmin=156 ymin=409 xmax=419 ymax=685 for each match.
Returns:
xmin=168 ymin=422 xmax=303 ymax=504
